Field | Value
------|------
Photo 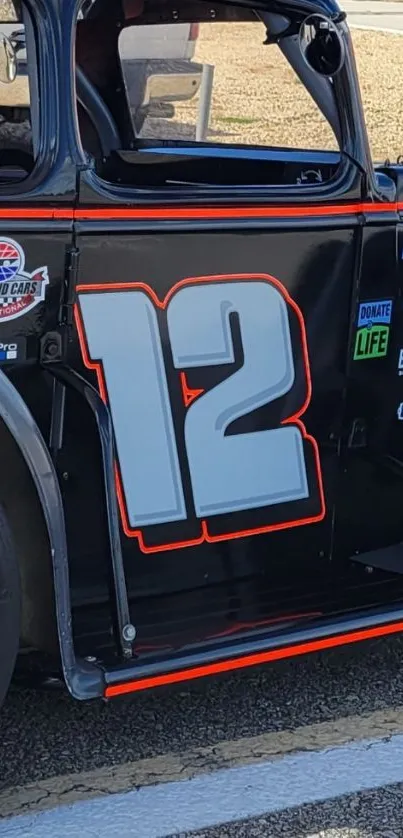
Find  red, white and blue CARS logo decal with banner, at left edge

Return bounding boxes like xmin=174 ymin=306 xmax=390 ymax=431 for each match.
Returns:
xmin=0 ymin=238 xmax=49 ymax=328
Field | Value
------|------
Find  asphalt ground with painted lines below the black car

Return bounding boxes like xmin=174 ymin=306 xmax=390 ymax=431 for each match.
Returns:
xmin=0 ymin=639 xmax=403 ymax=838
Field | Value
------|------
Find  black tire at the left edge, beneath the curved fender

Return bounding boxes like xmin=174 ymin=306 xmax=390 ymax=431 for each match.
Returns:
xmin=0 ymin=507 xmax=20 ymax=706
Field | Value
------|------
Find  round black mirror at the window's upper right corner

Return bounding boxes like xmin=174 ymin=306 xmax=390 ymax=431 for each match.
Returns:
xmin=299 ymin=14 xmax=345 ymax=77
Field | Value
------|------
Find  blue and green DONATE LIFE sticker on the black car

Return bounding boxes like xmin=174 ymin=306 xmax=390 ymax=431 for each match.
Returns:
xmin=354 ymin=300 xmax=393 ymax=361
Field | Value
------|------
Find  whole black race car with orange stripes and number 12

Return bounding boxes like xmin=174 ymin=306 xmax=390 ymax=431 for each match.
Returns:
xmin=0 ymin=0 xmax=403 ymax=712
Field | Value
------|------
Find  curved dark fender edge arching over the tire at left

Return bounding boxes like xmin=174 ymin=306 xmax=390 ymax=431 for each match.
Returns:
xmin=0 ymin=369 xmax=103 ymax=698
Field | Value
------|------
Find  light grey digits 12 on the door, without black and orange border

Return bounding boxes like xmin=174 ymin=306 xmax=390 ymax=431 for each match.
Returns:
xmin=79 ymin=278 xmax=320 ymax=548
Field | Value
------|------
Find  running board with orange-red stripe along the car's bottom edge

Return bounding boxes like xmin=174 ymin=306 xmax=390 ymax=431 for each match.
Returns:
xmin=69 ymin=607 xmax=403 ymax=699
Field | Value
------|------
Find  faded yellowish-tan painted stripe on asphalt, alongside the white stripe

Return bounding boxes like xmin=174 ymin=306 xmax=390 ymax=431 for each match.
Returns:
xmin=0 ymin=707 xmax=403 ymax=818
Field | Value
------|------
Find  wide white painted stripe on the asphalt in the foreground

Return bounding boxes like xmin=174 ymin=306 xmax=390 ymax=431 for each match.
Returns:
xmin=0 ymin=734 xmax=403 ymax=838
